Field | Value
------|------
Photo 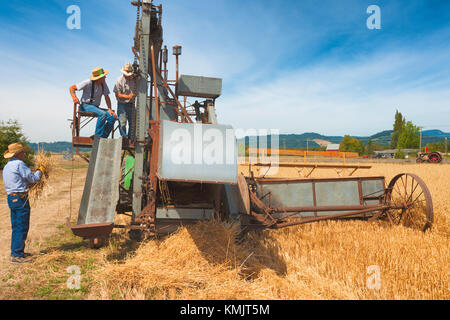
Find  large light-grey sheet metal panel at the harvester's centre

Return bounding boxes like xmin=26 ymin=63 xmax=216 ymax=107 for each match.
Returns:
xmin=158 ymin=121 xmax=241 ymax=184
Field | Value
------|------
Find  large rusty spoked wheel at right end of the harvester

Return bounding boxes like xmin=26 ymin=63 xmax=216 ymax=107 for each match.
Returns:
xmin=386 ymin=173 xmax=433 ymax=231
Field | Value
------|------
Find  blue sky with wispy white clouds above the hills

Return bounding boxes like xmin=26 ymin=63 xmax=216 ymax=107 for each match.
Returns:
xmin=0 ymin=0 xmax=450 ymax=142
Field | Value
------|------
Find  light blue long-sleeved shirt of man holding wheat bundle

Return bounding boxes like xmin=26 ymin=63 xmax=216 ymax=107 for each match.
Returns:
xmin=3 ymin=158 xmax=42 ymax=195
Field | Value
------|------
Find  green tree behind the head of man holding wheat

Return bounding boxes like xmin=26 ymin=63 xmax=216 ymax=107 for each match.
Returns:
xmin=0 ymin=120 xmax=34 ymax=169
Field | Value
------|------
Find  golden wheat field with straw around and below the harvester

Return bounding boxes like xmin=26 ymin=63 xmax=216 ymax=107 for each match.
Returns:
xmin=0 ymin=163 xmax=450 ymax=299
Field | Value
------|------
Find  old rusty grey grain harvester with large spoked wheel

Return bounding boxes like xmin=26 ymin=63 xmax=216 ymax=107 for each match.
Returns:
xmin=69 ymin=0 xmax=433 ymax=244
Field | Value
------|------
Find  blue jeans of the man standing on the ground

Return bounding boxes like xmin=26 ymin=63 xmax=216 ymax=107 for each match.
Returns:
xmin=8 ymin=195 xmax=30 ymax=257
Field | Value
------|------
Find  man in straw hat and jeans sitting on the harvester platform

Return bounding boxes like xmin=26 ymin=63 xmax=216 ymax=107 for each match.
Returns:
xmin=70 ymin=68 xmax=117 ymax=138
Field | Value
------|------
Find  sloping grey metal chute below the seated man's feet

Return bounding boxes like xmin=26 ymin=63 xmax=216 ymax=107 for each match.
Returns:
xmin=78 ymin=137 xmax=122 ymax=225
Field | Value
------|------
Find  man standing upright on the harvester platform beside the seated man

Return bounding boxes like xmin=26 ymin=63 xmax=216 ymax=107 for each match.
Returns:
xmin=114 ymin=63 xmax=137 ymax=139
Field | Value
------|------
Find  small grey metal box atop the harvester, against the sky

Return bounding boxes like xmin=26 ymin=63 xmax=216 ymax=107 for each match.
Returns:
xmin=176 ymin=74 xmax=222 ymax=99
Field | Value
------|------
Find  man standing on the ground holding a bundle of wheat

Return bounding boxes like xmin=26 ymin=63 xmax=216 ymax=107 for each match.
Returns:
xmin=3 ymin=143 xmax=45 ymax=263
